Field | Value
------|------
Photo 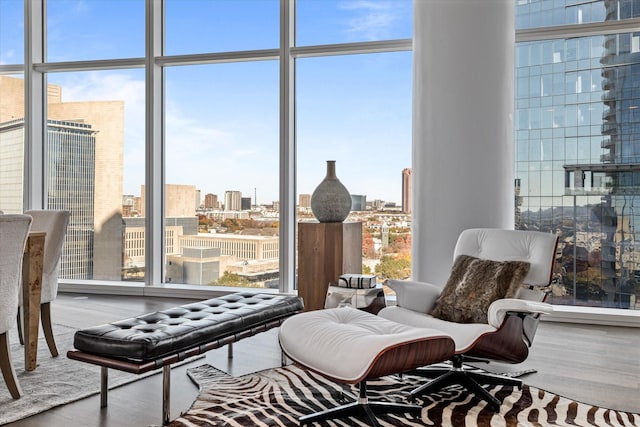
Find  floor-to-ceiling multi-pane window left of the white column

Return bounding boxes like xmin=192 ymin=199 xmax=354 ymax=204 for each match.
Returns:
xmin=0 ymin=0 xmax=412 ymax=290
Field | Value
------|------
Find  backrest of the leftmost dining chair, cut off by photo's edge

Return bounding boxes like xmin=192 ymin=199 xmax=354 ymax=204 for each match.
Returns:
xmin=0 ymin=214 xmax=32 ymax=333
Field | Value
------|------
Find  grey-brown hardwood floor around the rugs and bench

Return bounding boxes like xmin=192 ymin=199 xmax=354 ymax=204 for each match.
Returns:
xmin=5 ymin=294 xmax=640 ymax=427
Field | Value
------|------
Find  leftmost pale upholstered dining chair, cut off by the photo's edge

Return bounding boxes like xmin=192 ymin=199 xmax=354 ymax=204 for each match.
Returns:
xmin=0 ymin=214 xmax=31 ymax=399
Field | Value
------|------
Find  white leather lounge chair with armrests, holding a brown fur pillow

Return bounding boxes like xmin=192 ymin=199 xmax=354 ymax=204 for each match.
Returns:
xmin=378 ymin=229 xmax=557 ymax=411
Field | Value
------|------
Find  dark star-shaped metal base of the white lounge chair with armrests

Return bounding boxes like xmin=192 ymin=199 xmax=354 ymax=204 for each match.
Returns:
xmin=409 ymin=355 xmax=522 ymax=412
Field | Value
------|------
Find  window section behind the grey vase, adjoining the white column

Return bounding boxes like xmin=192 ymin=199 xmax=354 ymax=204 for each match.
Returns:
xmin=296 ymin=0 xmax=413 ymax=288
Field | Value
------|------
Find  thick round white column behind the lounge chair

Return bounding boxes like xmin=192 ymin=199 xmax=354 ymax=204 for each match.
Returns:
xmin=412 ymin=0 xmax=515 ymax=284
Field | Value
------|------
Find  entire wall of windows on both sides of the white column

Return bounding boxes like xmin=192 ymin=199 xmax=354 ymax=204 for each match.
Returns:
xmin=6 ymin=0 xmax=640 ymax=309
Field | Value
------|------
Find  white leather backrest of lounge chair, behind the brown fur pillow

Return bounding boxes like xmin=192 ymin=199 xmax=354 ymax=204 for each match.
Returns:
xmin=453 ymin=228 xmax=558 ymax=286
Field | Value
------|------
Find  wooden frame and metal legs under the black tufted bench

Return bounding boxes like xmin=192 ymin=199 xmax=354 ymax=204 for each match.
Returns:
xmin=67 ymin=312 xmax=298 ymax=426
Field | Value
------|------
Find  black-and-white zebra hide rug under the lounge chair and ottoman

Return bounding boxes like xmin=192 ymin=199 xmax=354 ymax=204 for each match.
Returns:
xmin=170 ymin=365 xmax=640 ymax=427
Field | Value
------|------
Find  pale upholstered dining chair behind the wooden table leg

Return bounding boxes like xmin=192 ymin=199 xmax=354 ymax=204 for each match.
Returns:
xmin=18 ymin=210 xmax=70 ymax=357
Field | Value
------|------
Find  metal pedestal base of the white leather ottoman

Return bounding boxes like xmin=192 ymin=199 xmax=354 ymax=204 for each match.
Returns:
xmin=298 ymin=381 xmax=422 ymax=427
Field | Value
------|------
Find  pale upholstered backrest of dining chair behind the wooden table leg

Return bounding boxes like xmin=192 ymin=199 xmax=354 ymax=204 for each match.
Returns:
xmin=25 ymin=210 xmax=70 ymax=303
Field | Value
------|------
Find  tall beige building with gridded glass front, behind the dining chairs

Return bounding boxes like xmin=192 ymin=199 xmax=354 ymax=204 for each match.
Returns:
xmin=0 ymin=76 xmax=124 ymax=280
